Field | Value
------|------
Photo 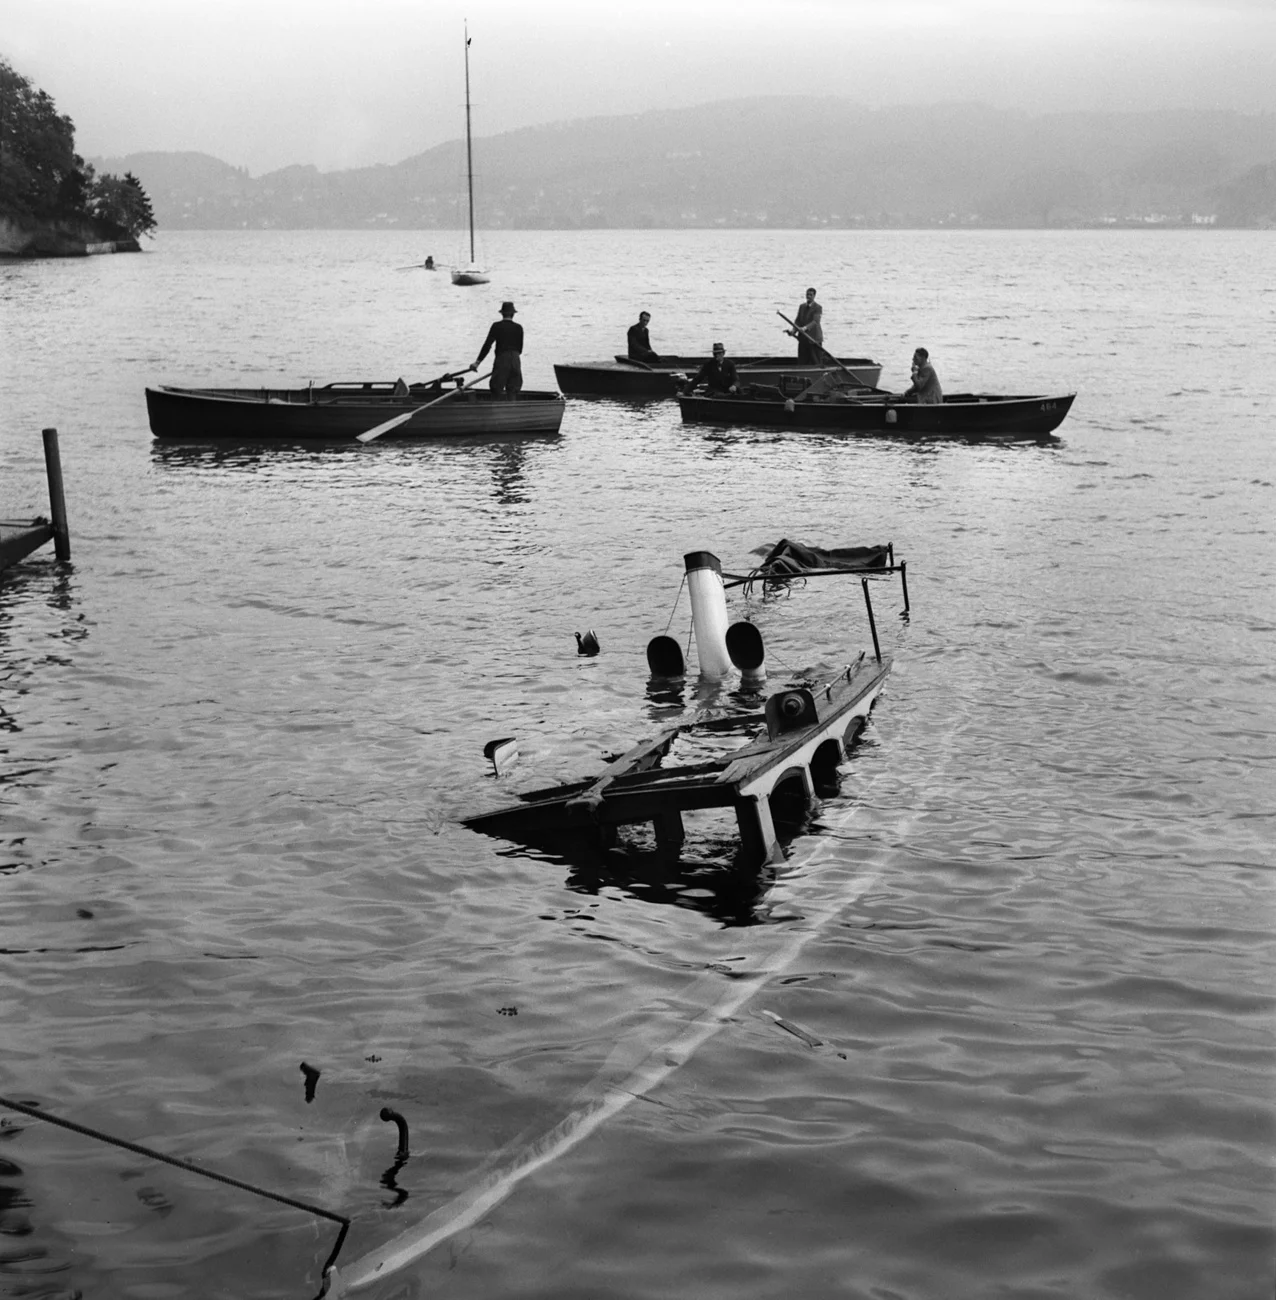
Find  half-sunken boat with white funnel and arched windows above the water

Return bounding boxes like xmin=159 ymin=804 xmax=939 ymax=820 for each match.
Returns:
xmin=463 ymin=541 xmax=907 ymax=867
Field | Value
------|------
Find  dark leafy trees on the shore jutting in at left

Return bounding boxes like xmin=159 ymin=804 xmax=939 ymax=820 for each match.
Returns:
xmin=0 ymin=57 xmax=156 ymax=239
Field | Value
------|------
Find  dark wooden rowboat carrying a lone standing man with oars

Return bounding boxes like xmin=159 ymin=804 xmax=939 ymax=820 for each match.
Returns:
xmin=147 ymin=382 xmax=567 ymax=441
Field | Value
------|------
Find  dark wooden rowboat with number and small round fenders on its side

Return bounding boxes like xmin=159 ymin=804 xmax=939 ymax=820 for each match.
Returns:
xmin=678 ymin=393 xmax=1076 ymax=438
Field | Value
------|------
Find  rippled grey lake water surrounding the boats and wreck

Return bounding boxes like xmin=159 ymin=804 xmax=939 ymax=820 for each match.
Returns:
xmin=0 ymin=231 xmax=1276 ymax=1300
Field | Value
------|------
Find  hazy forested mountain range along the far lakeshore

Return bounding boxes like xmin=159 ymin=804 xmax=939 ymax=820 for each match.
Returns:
xmin=90 ymin=98 xmax=1276 ymax=230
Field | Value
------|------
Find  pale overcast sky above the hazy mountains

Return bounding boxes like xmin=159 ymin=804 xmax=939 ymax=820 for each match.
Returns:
xmin=0 ymin=0 xmax=1276 ymax=176
